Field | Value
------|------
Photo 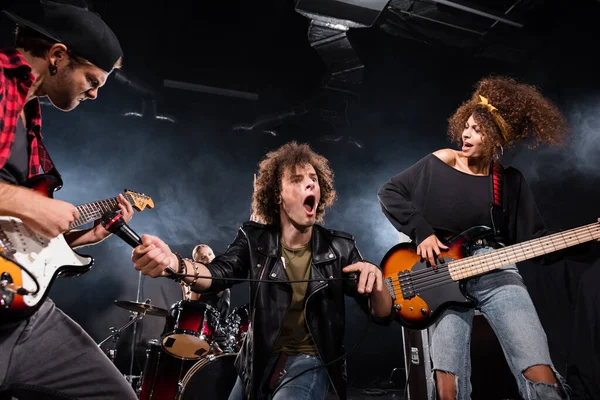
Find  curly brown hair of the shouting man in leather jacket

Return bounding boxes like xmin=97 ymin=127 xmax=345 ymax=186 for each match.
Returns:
xmin=252 ymin=141 xmax=336 ymax=224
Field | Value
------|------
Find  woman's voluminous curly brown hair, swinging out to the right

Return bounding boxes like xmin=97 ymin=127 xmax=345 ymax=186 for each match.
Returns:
xmin=448 ymin=76 xmax=569 ymax=157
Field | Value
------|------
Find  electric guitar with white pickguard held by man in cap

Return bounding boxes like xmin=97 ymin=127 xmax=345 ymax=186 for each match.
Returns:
xmin=0 ymin=175 xmax=154 ymax=324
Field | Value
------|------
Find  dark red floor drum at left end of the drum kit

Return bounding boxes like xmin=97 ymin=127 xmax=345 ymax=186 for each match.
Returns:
xmin=140 ymin=339 xmax=194 ymax=400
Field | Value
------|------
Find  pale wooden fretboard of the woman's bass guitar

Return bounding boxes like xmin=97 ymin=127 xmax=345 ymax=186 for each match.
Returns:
xmin=448 ymin=222 xmax=600 ymax=281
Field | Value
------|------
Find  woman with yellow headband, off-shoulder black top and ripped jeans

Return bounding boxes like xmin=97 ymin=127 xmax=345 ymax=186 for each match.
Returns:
xmin=378 ymin=77 xmax=580 ymax=399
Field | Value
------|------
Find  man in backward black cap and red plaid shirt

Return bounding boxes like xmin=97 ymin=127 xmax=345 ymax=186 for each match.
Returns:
xmin=0 ymin=0 xmax=136 ymax=400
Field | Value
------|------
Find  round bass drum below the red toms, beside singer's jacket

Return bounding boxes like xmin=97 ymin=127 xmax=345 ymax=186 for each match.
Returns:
xmin=177 ymin=353 xmax=237 ymax=400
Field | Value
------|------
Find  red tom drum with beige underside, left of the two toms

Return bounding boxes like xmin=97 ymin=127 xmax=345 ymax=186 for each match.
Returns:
xmin=161 ymin=300 xmax=219 ymax=360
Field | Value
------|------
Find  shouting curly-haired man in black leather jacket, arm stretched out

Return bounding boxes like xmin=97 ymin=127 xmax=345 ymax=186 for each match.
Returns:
xmin=132 ymin=142 xmax=393 ymax=400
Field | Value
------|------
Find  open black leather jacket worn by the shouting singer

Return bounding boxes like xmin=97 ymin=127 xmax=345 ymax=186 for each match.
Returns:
xmin=208 ymin=222 xmax=392 ymax=399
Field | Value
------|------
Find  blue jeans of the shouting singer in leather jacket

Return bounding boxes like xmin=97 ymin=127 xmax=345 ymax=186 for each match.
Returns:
xmin=229 ymin=354 xmax=329 ymax=400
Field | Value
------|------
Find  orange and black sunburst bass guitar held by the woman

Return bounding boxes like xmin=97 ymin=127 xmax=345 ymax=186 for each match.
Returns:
xmin=381 ymin=222 xmax=600 ymax=329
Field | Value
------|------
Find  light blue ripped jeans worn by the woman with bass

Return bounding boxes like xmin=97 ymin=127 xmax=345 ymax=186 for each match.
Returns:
xmin=429 ymin=248 xmax=568 ymax=400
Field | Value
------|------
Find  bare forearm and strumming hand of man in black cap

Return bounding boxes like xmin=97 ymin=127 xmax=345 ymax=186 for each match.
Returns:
xmin=0 ymin=183 xmax=79 ymax=239
